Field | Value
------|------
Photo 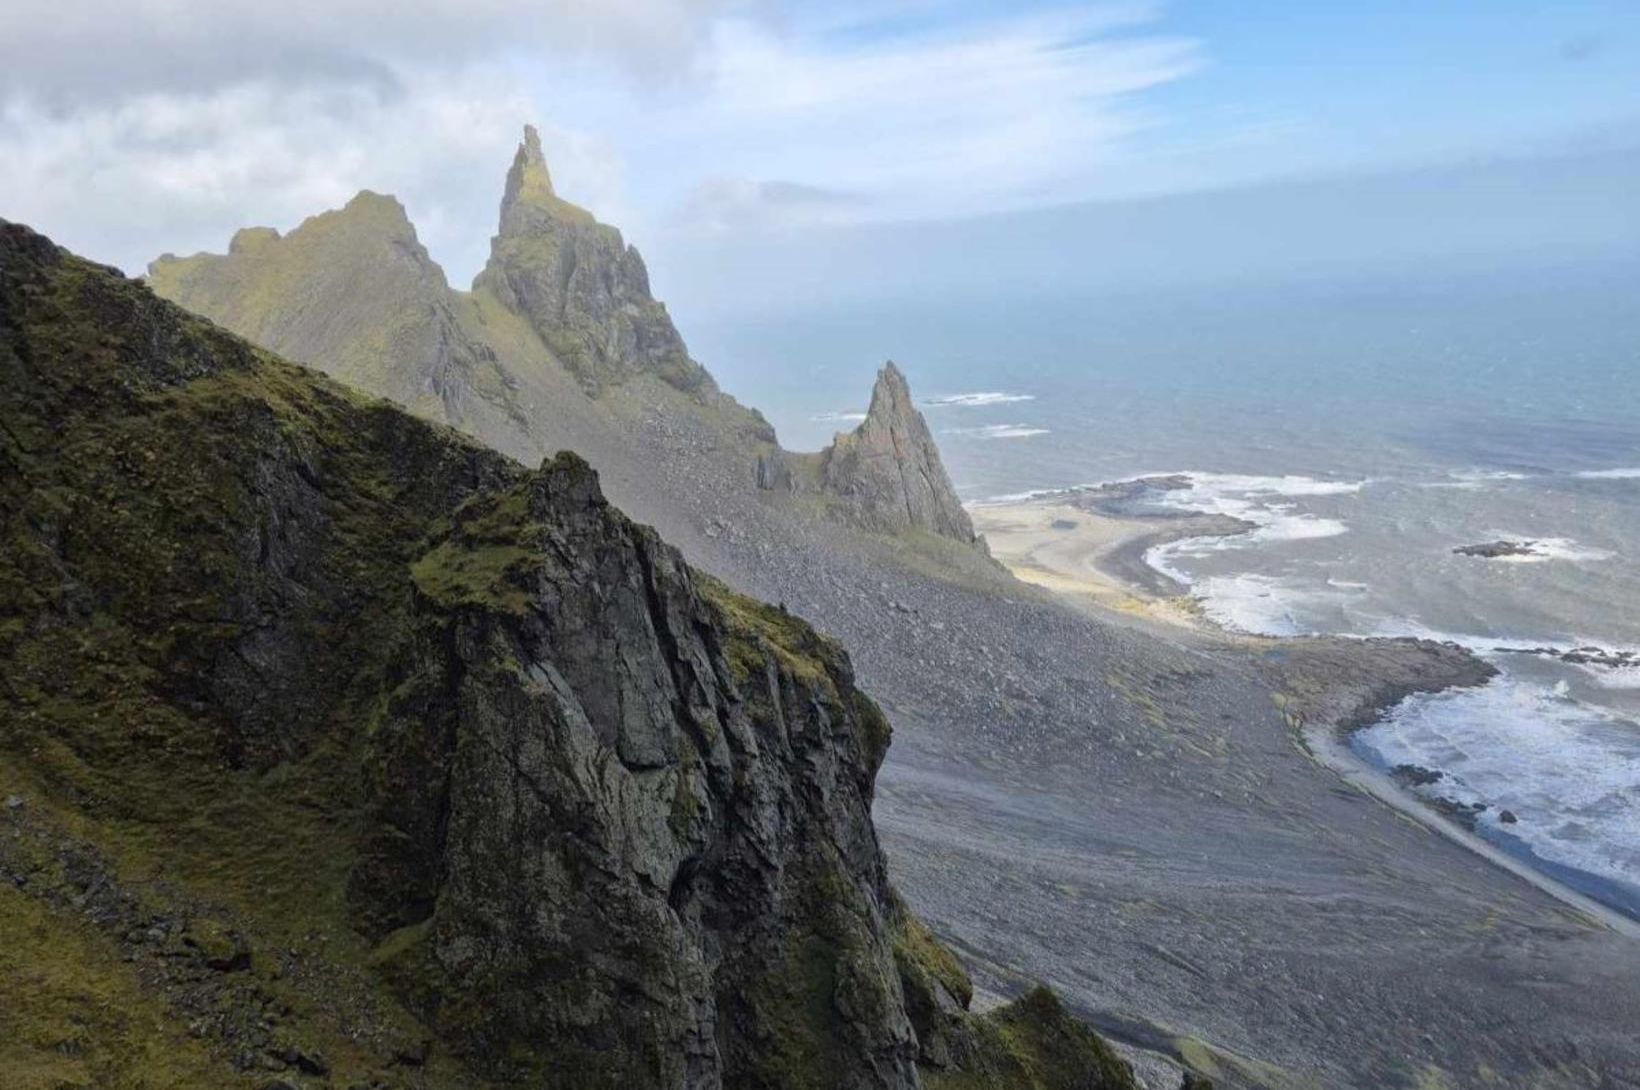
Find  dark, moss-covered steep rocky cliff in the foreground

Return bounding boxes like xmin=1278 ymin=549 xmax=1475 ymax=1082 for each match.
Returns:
xmin=0 ymin=225 xmax=1130 ymax=1090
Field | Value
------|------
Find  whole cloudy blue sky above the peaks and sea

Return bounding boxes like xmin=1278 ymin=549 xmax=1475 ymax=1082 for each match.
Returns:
xmin=0 ymin=0 xmax=1640 ymax=288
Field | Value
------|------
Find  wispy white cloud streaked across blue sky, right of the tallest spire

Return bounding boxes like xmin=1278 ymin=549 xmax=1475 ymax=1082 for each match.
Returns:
xmin=642 ymin=10 xmax=1200 ymax=220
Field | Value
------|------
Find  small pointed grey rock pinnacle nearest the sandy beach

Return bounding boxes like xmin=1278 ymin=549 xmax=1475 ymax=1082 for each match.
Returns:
xmin=820 ymin=362 xmax=977 ymax=543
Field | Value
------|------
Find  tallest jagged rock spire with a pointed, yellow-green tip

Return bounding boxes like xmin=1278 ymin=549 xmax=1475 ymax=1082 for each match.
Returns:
xmin=474 ymin=126 xmax=717 ymax=398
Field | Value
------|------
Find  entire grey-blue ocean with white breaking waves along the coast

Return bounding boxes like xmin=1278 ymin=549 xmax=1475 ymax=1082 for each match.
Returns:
xmin=686 ymin=259 xmax=1640 ymax=915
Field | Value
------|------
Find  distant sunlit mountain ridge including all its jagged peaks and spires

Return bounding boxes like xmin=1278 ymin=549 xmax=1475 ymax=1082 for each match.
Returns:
xmin=148 ymin=126 xmax=976 ymax=557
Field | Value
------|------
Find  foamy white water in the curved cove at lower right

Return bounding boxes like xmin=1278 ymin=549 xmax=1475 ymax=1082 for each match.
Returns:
xmin=1355 ymin=674 xmax=1640 ymax=892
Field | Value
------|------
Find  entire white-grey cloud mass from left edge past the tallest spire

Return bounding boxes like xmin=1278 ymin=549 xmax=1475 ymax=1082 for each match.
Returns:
xmin=0 ymin=0 xmax=1199 ymax=284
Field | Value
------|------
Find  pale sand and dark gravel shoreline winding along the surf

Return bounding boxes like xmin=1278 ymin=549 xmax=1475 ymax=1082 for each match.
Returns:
xmin=969 ymin=490 xmax=1640 ymax=938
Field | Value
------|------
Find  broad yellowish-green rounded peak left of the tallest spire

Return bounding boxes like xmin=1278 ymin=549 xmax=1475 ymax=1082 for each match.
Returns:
xmin=148 ymin=193 xmax=517 ymax=425
